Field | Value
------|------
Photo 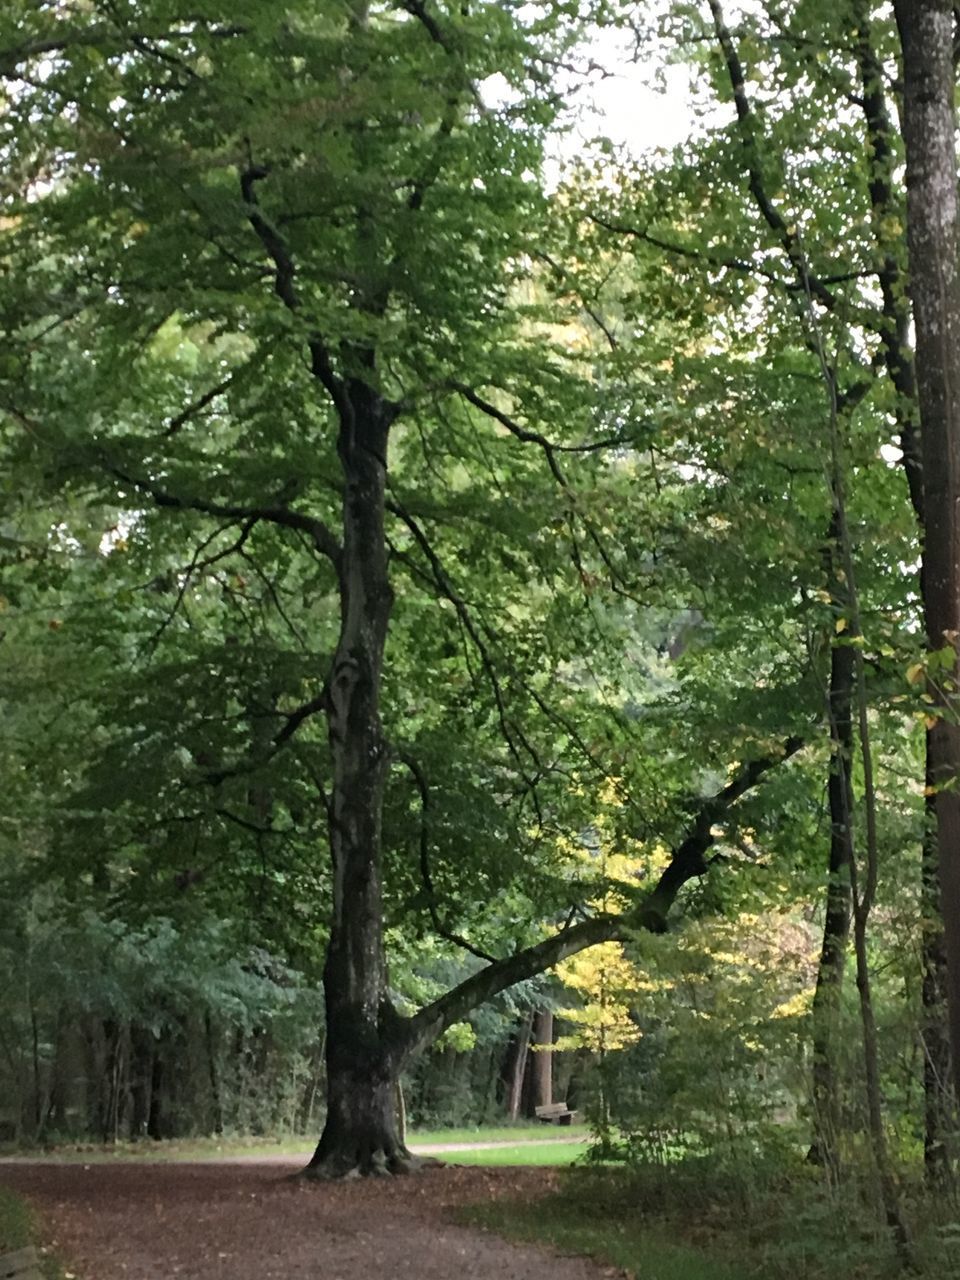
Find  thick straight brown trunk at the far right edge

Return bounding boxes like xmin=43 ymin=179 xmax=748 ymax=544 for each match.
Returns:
xmin=895 ymin=0 xmax=960 ymax=1100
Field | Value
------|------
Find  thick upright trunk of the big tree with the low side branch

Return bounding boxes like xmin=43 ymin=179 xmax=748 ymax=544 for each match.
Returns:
xmin=306 ymin=380 xmax=410 ymax=1178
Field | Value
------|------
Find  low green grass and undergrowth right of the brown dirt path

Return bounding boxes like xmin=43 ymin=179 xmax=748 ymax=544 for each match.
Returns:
xmin=462 ymin=1160 xmax=960 ymax=1280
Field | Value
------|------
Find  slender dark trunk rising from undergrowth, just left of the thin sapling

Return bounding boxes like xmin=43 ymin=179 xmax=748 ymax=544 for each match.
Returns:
xmin=809 ymin=644 xmax=854 ymax=1174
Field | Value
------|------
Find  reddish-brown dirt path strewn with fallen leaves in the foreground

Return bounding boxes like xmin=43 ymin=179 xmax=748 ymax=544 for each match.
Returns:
xmin=0 ymin=1164 xmax=609 ymax=1280
